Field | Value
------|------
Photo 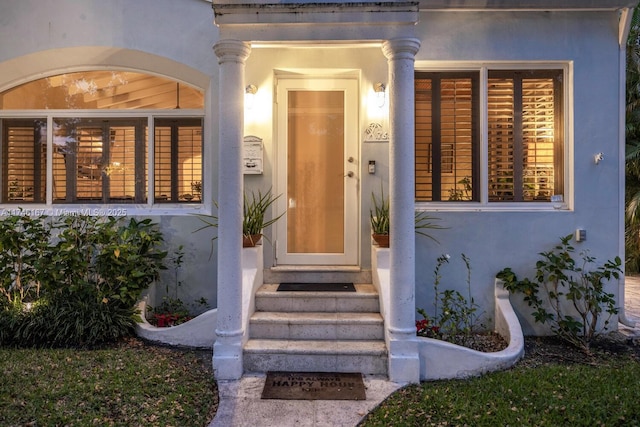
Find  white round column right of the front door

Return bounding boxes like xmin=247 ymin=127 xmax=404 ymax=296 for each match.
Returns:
xmin=382 ymin=38 xmax=420 ymax=382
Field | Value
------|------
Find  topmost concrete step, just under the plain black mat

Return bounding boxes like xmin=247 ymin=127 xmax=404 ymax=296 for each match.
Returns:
xmin=255 ymin=284 xmax=380 ymax=313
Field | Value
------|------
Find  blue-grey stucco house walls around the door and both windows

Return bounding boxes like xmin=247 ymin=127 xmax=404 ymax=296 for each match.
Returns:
xmin=0 ymin=0 xmax=623 ymax=334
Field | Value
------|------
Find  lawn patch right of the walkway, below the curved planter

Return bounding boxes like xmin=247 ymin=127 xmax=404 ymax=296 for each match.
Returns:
xmin=360 ymin=350 xmax=640 ymax=427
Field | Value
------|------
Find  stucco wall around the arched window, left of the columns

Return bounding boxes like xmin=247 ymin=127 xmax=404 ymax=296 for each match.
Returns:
xmin=0 ymin=0 xmax=218 ymax=311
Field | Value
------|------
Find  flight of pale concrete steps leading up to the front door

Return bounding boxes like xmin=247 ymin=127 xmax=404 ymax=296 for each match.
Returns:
xmin=244 ymin=284 xmax=387 ymax=375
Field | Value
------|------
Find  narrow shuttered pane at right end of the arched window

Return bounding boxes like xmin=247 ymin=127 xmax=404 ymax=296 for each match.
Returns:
xmin=154 ymin=119 xmax=202 ymax=202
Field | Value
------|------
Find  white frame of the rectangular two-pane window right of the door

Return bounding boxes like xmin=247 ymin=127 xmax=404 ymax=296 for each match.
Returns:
xmin=414 ymin=60 xmax=574 ymax=212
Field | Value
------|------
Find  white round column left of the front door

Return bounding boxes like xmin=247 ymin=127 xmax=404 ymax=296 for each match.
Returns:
xmin=213 ymin=40 xmax=251 ymax=380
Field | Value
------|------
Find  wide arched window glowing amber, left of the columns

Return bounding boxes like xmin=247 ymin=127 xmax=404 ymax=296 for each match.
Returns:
xmin=0 ymin=71 xmax=204 ymax=204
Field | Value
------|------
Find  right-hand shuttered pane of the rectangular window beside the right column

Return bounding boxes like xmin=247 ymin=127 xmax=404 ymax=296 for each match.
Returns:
xmin=487 ymin=70 xmax=564 ymax=202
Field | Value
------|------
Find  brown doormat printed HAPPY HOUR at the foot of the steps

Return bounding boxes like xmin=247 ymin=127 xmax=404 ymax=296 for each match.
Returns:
xmin=262 ymin=372 xmax=367 ymax=400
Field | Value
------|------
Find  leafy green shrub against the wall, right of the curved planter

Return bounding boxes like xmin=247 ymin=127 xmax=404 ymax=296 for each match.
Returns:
xmin=496 ymin=234 xmax=622 ymax=352
